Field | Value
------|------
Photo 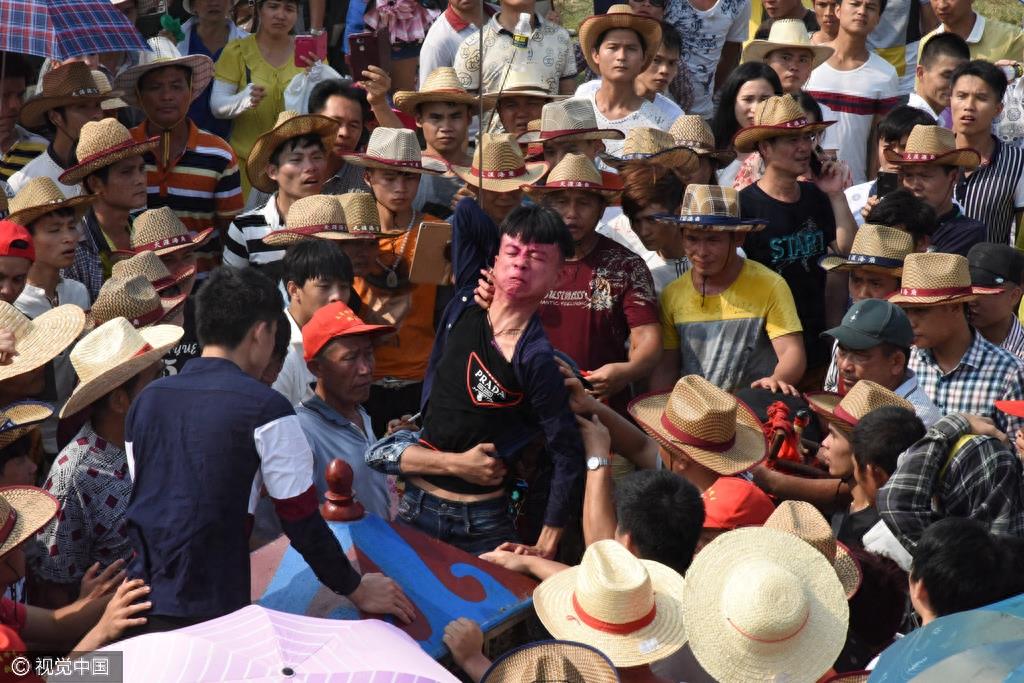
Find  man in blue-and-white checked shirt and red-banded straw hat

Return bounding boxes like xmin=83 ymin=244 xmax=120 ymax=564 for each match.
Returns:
xmin=889 ymin=253 xmax=1024 ymax=434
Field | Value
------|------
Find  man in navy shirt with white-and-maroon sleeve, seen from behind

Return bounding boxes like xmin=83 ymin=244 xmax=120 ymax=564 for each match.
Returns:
xmin=125 ymin=267 xmax=414 ymax=635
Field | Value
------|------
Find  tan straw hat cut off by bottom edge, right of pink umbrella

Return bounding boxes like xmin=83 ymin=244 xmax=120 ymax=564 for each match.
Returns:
xmin=480 ymin=640 xmax=618 ymax=683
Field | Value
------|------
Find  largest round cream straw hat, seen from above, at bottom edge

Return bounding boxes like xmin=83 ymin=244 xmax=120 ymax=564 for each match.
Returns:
xmin=683 ymin=527 xmax=850 ymax=683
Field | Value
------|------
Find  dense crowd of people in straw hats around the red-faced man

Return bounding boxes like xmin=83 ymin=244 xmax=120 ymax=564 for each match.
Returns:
xmin=0 ymin=0 xmax=1024 ymax=683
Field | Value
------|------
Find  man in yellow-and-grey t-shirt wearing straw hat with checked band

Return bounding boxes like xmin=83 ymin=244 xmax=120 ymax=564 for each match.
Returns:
xmin=650 ymin=184 xmax=807 ymax=391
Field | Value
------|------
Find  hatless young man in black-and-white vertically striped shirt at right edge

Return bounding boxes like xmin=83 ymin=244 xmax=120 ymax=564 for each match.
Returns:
xmin=949 ymin=59 xmax=1024 ymax=246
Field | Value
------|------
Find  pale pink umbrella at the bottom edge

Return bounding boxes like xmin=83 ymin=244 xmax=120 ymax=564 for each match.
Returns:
xmin=100 ymin=605 xmax=459 ymax=683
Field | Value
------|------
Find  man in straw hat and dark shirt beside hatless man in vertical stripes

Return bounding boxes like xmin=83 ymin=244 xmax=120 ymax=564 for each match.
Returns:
xmin=885 ymin=125 xmax=987 ymax=256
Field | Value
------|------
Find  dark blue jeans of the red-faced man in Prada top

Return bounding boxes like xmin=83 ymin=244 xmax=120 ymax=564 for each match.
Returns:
xmin=398 ymin=483 xmax=516 ymax=555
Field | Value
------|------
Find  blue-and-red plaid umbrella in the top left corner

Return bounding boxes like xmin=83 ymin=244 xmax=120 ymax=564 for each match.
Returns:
xmin=0 ymin=0 xmax=150 ymax=60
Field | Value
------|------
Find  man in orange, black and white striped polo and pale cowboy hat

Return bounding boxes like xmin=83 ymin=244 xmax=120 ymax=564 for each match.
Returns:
xmin=115 ymin=37 xmax=243 ymax=279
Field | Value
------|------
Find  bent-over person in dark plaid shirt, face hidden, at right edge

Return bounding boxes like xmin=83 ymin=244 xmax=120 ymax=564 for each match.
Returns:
xmin=878 ymin=415 xmax=1024 ymax=553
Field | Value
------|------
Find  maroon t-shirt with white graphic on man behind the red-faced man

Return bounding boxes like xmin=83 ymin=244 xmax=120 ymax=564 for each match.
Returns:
xmin=541 ymin=236 xmax=658 ymax=407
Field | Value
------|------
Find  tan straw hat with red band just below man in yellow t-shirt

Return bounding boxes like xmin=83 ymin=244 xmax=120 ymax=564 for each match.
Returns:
xmin=628 ymin=375 xmax=768 ymax=475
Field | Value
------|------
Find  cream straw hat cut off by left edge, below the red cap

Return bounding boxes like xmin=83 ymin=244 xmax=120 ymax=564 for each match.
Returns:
xmin=0 ymin=301 xmax=85 ymax=381
